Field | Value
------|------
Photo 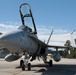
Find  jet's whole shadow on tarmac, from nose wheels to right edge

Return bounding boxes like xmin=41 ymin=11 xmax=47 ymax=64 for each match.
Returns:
xmin=16 ymin=64 xmax=76 ymax=75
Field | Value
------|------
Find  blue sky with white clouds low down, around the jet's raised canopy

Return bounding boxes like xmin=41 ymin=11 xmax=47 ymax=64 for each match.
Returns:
xmin=0 ymin=0 xmax=76 ymax=45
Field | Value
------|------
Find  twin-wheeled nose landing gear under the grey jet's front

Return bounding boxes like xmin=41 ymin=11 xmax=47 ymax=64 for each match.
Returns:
xmin=20 ymin=54 xmax=31 ymax=71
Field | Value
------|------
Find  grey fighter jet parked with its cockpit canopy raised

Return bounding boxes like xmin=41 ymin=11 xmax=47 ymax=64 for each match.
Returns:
xmin=0 ymin=3 xmax=73 ymax=70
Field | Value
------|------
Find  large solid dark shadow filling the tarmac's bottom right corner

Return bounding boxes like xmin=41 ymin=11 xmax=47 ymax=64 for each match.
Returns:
xmin=41 ymin=64 xmax=76 ymax=75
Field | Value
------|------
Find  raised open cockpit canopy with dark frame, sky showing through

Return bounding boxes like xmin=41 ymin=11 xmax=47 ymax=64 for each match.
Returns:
xmin=19 ymin=3 xmax=37 ymax=34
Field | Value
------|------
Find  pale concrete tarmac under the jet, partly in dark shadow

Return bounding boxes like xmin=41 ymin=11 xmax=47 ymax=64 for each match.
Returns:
xmin=0 ymin=58 xmax=76 ymax=75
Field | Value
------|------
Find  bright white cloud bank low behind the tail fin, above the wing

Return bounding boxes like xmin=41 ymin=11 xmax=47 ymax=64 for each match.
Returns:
xmin=38 ymin=32 xmax=71 ymax=45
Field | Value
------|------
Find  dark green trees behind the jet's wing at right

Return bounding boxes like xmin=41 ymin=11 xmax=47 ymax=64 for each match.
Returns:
xmin=59 ymin=40 xmax=76 ymax=58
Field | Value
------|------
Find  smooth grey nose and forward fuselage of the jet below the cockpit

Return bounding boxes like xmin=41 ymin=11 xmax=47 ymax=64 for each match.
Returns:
xmin=0 ymin=27 xmax=38 ymax=53
